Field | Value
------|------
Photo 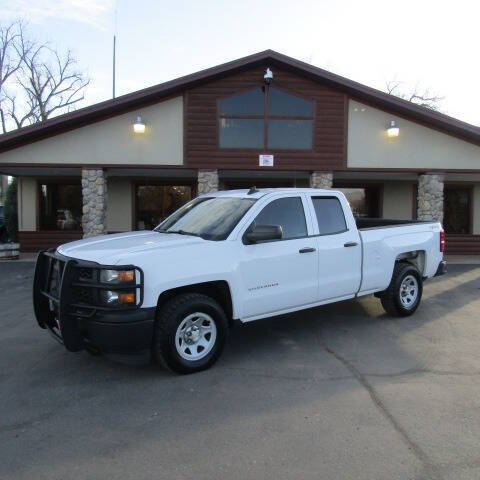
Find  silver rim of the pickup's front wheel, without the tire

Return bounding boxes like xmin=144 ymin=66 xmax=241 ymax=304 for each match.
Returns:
xmin=175 ymin=312 xmax=217 ymax=361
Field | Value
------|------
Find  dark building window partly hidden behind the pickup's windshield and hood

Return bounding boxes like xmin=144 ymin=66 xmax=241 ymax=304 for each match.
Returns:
xmin=135 ymin=185 xmax=193 ymax=230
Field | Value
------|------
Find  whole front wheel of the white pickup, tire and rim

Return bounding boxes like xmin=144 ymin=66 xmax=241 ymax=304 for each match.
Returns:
xmin=153 ymin=293 xmax=228 ymax=374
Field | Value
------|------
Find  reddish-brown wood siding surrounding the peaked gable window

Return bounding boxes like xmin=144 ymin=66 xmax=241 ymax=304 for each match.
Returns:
xmin=184 ymin=64 xmax=348 ymax=170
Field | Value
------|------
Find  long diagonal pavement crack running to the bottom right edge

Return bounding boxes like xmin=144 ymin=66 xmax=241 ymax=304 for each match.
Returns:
xmin=319 ymin=339 xmax=443 ymax=480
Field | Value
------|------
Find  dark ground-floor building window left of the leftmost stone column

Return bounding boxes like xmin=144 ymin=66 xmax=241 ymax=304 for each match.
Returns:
xmin=39 ymin=182 xmax=82 ymax=231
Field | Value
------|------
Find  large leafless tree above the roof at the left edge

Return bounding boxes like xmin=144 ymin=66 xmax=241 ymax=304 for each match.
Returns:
xmin=0 ymin=22 xmax=89 ymax=132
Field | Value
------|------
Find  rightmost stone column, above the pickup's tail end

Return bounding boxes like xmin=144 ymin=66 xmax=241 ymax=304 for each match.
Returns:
xmin=417 ymin=173 xmax=443 ymax=222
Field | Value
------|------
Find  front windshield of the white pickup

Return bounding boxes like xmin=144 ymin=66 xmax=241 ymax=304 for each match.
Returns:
xmin=155 ymin=197 xmax=255 ymax=240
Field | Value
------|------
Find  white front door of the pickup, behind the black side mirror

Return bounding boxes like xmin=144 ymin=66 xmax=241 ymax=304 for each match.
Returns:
xmin=239 ymin=194 xmax=318 ymax=318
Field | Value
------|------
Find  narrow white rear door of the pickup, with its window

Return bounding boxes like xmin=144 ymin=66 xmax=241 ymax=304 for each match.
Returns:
xmin=308 ymin=195 xmax=362 ymax=301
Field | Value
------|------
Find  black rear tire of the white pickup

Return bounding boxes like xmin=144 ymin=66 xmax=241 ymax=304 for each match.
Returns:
xmin=379 ymin=263 xmax=423 ymax=317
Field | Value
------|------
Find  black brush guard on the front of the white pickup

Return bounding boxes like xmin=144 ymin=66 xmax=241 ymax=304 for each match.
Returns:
xmin=33 ymin=249 xmax=143 ymax=352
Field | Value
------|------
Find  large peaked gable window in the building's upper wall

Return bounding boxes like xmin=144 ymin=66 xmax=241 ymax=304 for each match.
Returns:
xmin=219 ymin=87 xmax=313 ymax=150
